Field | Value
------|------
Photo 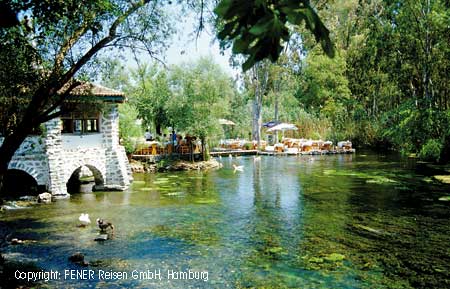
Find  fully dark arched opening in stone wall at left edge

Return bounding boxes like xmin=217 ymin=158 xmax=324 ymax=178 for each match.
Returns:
xmin=3 ymin=169 xmax=43 ymax=196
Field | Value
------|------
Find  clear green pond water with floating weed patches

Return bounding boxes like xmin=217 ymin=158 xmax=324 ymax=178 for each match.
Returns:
xmin=0 ymin=155 xmax=450 ymax=288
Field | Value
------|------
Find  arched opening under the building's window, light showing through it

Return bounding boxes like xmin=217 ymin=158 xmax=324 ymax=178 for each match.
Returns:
xmin=66 ymin=165 xmax=104 ymax=194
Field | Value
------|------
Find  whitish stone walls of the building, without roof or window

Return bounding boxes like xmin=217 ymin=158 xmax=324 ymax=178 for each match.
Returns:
xmin=0 ymin=104 xmax=133 ymax=197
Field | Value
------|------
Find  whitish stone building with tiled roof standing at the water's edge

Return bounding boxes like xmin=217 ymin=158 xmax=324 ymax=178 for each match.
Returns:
xmin=0 ymin=83 xmax=132 ymax=197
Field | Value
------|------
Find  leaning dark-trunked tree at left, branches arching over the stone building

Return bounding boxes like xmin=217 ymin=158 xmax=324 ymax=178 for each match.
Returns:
xmin=0 ymin=0 xmax=171 ymax=189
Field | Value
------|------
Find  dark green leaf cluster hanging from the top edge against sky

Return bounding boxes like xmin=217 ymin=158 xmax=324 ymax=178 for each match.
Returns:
xmin=214 ymin=0 xmax=334 ymax=71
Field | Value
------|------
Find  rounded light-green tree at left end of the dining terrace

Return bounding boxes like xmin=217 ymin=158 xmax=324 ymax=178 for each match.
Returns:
xmin=166 ymin=58 xmax=234 ymax=158
